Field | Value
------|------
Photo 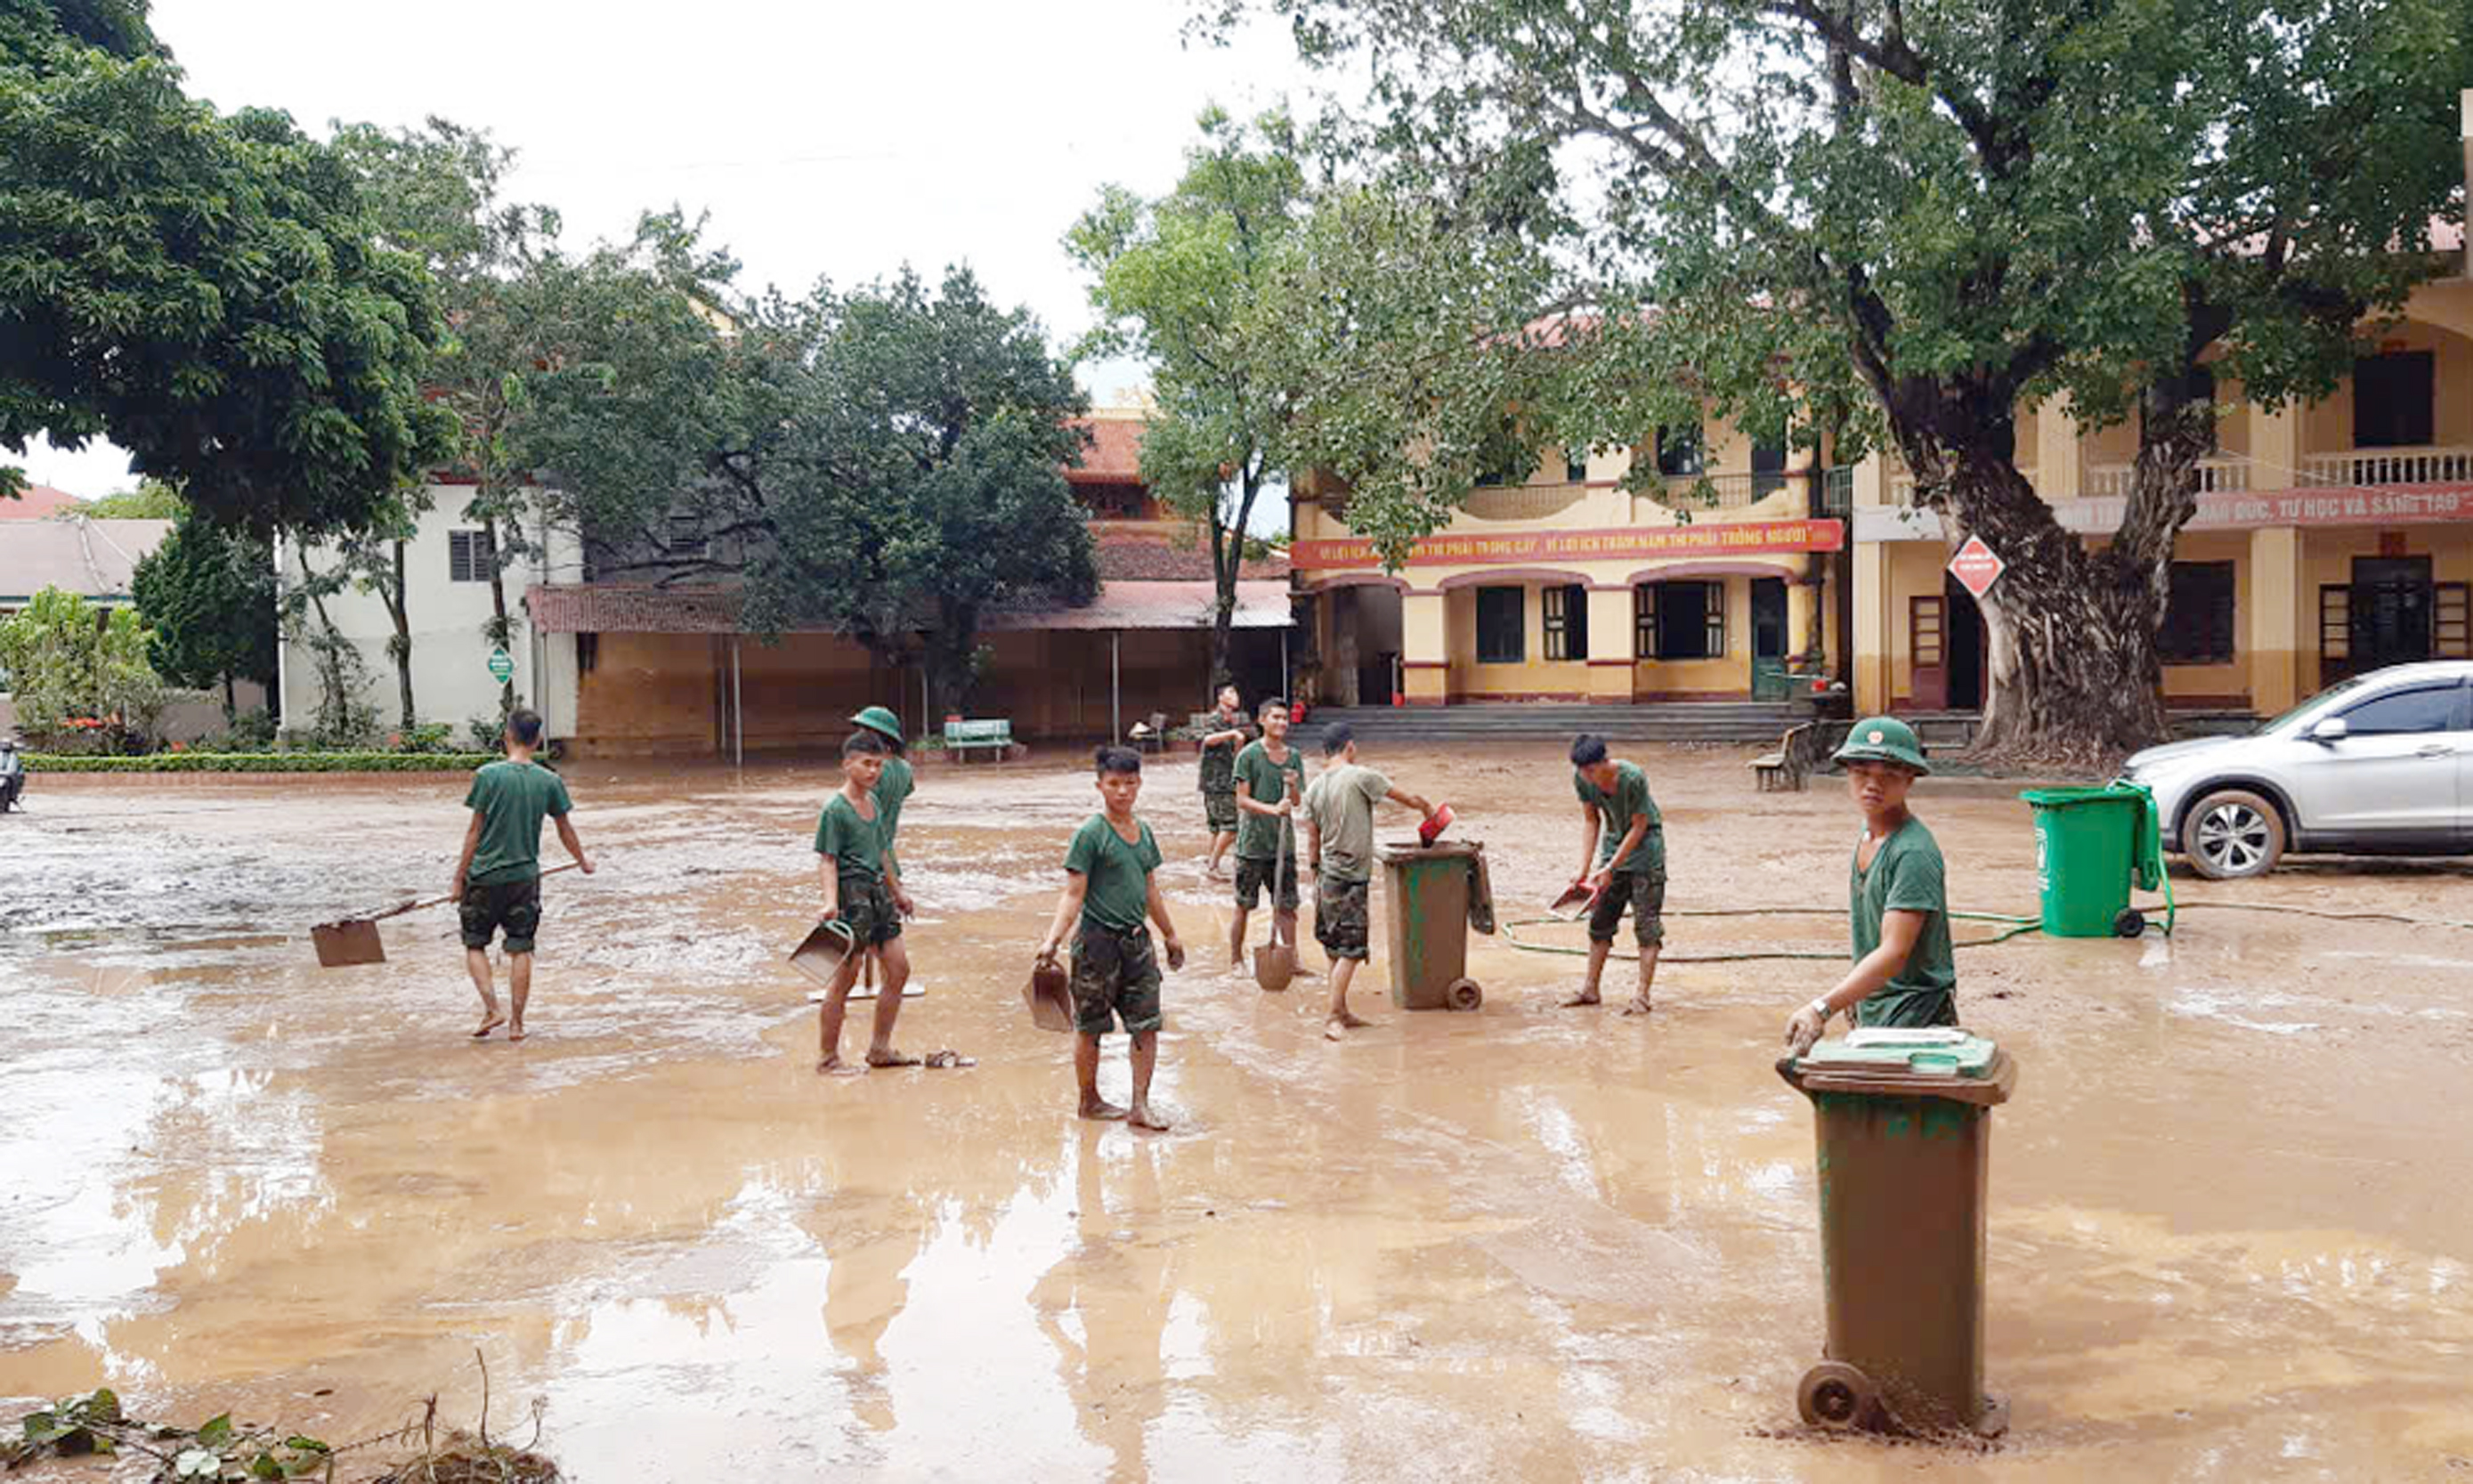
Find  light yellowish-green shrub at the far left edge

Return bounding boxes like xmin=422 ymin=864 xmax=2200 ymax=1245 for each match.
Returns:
xmin=0 ymin=588 xmax=168 ymax=747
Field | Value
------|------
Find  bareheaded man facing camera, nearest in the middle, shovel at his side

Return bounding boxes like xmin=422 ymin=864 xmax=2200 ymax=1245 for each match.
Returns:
xmin=1039 ymin=747 xmax=1185 ymax=1131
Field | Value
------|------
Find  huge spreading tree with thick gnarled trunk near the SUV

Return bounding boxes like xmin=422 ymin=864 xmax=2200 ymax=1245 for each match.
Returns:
xmin=1221 ymin=0 xmax=2473 ymax=762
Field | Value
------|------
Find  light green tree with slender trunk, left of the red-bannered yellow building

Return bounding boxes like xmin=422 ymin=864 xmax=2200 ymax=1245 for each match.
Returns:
xmin=1066 ymin=109 xmax=1545 ymax=683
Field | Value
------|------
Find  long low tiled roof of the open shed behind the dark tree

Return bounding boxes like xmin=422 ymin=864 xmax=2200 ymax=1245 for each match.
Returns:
xmin=527 ymin=581 xmax=1288 ymax=633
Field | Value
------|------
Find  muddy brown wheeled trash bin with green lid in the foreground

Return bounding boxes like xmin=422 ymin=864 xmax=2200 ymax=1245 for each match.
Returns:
xmin=1778 ymin=1026 xmax=2018 ymax=1437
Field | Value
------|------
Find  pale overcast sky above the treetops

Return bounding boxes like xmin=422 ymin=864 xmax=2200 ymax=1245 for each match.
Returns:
xmin=14 ymin=0 xmax=1309 ymax=497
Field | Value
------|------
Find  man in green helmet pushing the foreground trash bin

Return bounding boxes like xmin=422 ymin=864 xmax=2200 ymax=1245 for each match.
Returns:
xmin=1786 ymin=718 xmax=1958 ymax=1056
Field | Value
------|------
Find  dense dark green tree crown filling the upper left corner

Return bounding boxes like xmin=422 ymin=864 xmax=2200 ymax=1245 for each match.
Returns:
xmin=0 ymin=0 xmax=445 ymax=531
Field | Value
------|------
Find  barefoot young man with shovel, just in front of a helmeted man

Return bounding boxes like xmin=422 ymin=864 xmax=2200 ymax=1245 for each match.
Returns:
xmin=816 ymin=727 xmax=920 ymax=1076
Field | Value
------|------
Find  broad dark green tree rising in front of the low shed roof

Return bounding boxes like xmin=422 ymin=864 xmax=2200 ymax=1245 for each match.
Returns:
xmin=527 ymin=259 xmax=1098 ymax=705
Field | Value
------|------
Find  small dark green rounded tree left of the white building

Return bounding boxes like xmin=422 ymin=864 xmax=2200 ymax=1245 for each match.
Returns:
xmin=131 ymin=512 xmax=277 ymax=710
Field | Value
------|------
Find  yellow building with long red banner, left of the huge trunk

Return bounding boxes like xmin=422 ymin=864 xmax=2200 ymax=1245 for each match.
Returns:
xmin=1288 ymin=420 xmax=1853 ymax=708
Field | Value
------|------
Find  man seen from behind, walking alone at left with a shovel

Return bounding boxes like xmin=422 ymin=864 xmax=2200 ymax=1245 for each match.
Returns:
xmin=448 ymin=708 xmax=594 ymax=1042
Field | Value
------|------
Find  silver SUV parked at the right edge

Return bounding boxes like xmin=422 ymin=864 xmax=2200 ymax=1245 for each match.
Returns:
xmin=2122 ymin=661 xmax=2473 ymax=880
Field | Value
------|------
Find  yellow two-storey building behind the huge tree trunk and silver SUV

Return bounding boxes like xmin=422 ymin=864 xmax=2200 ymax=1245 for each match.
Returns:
xmin=1853 ymin=271 xmax=2473 ymax=715
